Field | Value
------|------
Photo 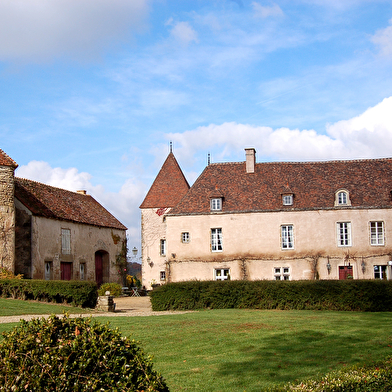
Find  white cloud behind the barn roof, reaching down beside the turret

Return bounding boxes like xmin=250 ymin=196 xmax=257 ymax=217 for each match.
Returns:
xmin=16 ymin=161 xmax=147 ymax=248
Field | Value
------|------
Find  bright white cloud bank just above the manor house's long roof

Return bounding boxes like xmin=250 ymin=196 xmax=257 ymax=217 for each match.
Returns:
xmin=167 ymin=97 xmax=392 ymax=163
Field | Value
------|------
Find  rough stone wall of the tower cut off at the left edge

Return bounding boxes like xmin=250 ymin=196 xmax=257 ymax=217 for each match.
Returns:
xmin=0 ymin=166 xmax=15 ymax=271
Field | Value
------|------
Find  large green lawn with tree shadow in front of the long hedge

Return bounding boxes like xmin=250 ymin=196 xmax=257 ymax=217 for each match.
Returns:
xmin=0 ymin=309 xmax=392 ymax=392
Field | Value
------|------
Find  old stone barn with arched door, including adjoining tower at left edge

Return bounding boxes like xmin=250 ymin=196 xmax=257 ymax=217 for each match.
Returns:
xmin=0 ymin=150 xmax=126 ymax=284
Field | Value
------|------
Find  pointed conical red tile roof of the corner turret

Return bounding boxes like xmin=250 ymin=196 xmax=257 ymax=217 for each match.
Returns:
xmin=140 ymin=152 xmax=189 ymax=208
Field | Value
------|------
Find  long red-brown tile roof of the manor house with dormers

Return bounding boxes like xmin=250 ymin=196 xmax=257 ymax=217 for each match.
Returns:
xmin=170 ymin=158 xmax=392 ymax=215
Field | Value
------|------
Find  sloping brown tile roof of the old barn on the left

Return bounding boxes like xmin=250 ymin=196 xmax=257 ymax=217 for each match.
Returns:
xmin=15 ymin=177 xmax=127 ymax=230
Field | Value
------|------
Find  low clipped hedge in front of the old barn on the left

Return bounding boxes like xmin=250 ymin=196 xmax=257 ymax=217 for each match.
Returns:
xmin=0 ymin=279 xmax=98 ymax=308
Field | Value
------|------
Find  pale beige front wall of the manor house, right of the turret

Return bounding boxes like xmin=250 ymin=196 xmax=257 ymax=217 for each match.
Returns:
xmin=165 ymin=208 xmax=392 ymax=282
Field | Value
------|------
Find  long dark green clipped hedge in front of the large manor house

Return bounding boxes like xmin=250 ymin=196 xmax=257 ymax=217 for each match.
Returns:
xmin=150 ymin=280 xmax=392 ymax=312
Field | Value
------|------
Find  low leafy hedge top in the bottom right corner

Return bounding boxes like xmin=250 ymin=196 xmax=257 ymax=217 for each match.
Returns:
xmin=268 ymin=357 xmax=392 ymax=392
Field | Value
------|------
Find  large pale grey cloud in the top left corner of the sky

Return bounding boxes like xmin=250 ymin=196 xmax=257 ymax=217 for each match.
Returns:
xmin=0 ymin=0 xmax=150 ymax=61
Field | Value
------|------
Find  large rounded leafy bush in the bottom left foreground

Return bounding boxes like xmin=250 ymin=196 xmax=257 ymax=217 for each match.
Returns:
xmin=0 ymin=315 xmax=168 ymax=392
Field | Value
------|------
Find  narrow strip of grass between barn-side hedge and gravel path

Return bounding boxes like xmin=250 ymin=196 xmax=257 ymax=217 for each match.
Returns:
xmin=0 ymin=298 xmax=91 ymax=317
